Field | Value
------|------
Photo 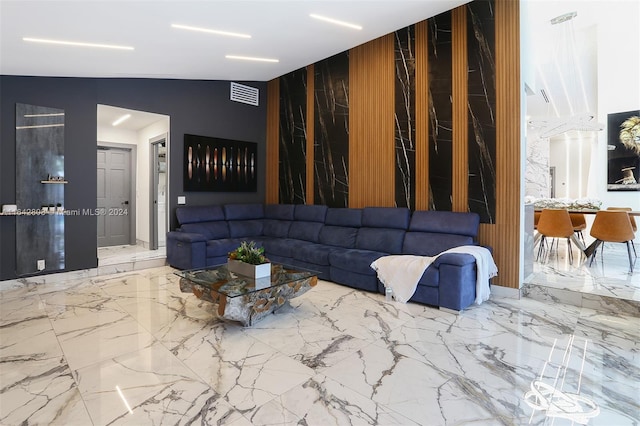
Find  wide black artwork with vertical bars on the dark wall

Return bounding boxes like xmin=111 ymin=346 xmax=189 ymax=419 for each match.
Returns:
xmin=183 ymin=134 xmax=258 ymax=192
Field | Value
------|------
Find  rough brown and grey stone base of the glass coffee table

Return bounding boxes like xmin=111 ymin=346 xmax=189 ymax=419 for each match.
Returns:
xmin=180 ymin=276 xmax=318 ymax=327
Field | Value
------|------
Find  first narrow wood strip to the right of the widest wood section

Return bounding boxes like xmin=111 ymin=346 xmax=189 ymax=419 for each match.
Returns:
xmin=415 ymin=21 xmax=429 ymax=210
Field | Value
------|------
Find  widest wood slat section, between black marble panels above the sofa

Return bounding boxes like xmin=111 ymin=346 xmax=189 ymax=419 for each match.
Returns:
xmin=349 ymin=34 xmax=395 ymax=207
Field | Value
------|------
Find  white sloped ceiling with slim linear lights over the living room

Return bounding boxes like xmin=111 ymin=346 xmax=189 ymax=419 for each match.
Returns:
xmin=0 ymin=0 xmax=468 ymax=81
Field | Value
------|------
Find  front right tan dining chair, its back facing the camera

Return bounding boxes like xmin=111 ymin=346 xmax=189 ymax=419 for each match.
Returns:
xmin=589 ymin=210 xmax=635 ymax=272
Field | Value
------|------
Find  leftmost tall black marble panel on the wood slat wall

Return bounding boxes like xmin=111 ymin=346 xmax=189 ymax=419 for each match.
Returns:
xmin=279 ymin=68 xmax=307 ymax=204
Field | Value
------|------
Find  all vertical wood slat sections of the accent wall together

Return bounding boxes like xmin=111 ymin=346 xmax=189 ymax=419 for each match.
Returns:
xmin=266 ymin=0 xmax=522 ymax=288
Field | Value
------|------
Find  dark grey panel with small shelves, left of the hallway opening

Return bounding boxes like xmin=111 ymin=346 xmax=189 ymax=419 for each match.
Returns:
xmin=16 ymin=104 xmax=65 ymax=276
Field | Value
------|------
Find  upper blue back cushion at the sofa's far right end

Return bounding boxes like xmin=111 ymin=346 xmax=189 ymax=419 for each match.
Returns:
xmin=409 ymin=210 xmax=480 ymax=240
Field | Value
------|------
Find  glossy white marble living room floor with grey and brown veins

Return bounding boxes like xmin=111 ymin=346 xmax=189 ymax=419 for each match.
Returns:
xmin=0 ymin=262 xmax=640 ymax=426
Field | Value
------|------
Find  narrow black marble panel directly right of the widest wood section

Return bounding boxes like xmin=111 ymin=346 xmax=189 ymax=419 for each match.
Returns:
xmin=394 ymin=25 xmax=416 ymax=210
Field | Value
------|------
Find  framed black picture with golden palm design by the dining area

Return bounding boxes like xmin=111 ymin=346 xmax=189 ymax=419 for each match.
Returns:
xmin=607 ymin=110 xmax=640 ymax=191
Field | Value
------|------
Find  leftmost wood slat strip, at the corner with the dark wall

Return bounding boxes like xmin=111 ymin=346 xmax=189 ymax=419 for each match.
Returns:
xmin=264 ymin=78 xmax=280 ymax=204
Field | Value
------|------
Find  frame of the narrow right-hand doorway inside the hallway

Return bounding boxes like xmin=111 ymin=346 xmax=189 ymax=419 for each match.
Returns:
xmin=149 ymin=133 xmax=169 ymax=250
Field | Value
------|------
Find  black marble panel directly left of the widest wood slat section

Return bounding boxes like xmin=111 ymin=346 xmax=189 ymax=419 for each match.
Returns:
xmin=314 ymin=51 xmax=349 ymax=207
